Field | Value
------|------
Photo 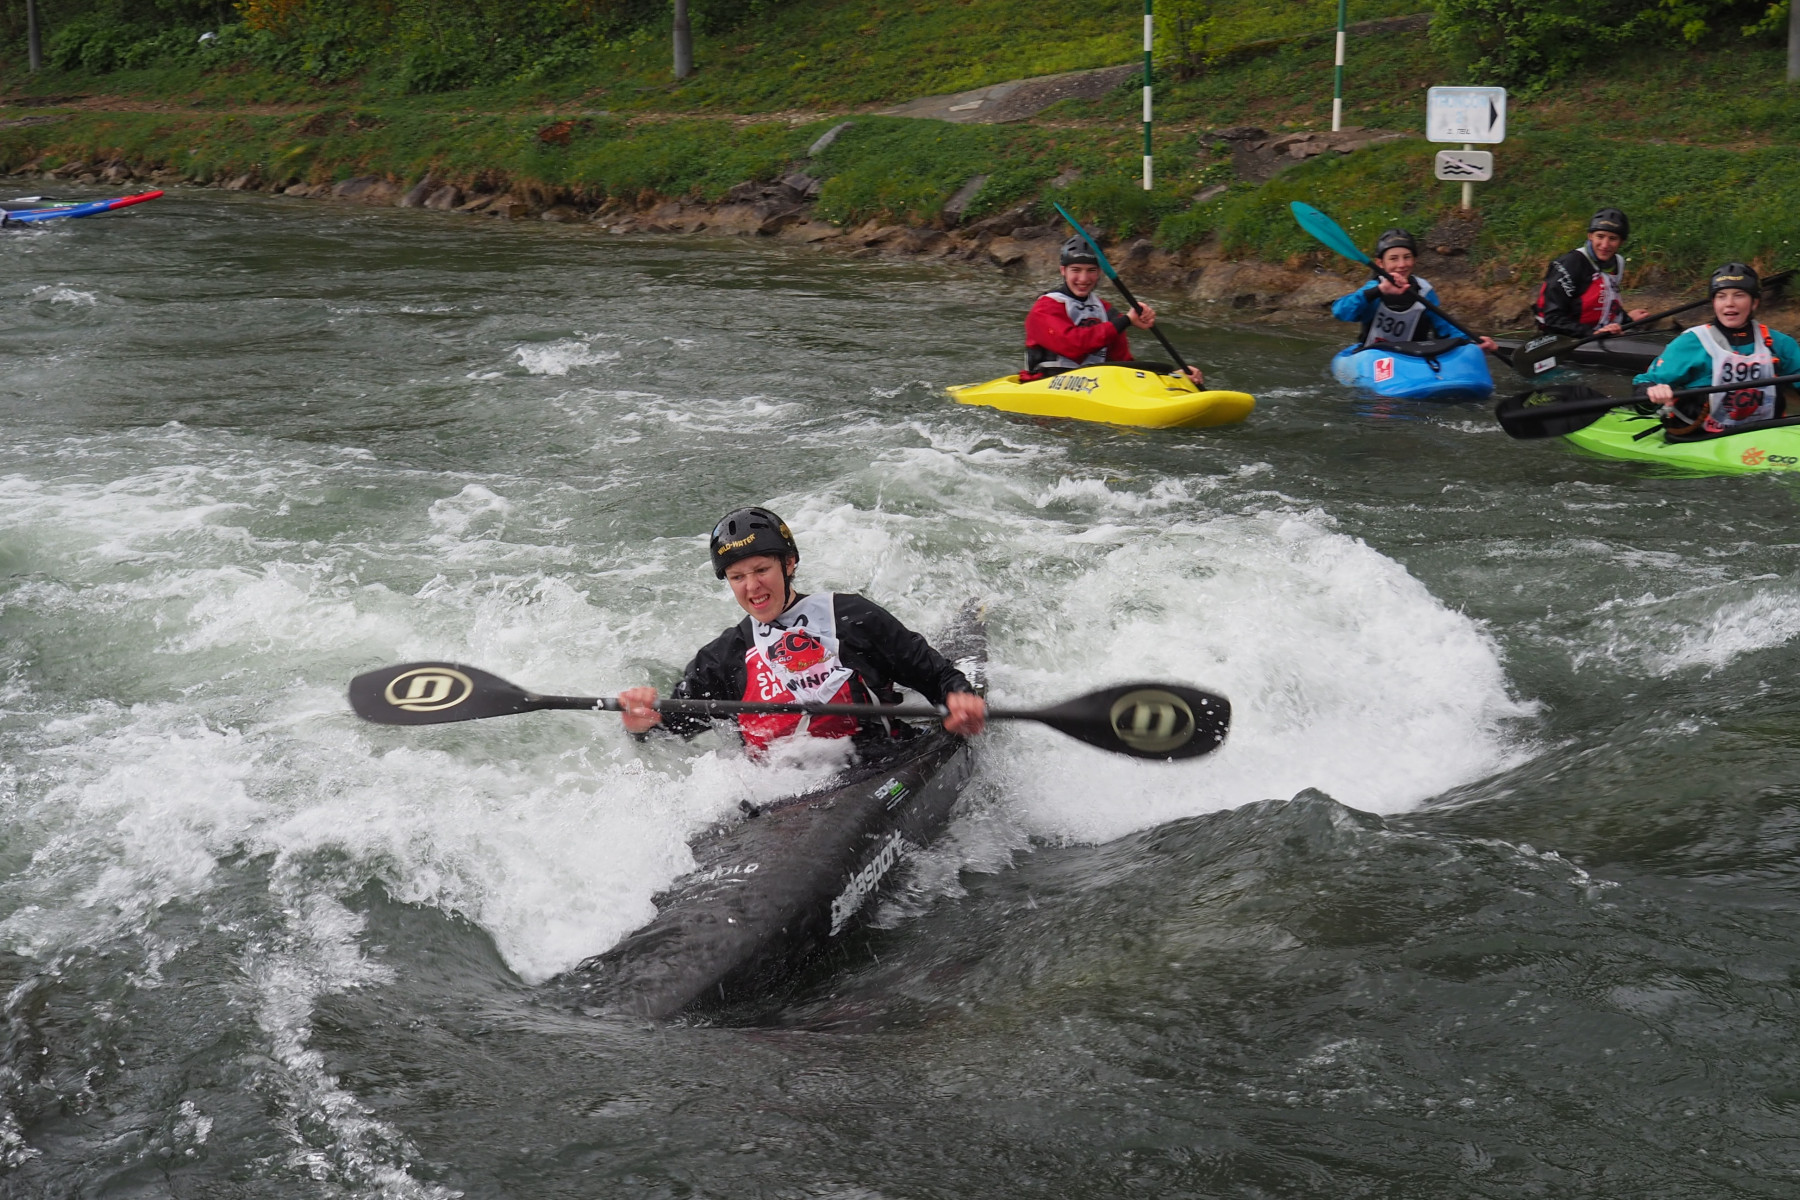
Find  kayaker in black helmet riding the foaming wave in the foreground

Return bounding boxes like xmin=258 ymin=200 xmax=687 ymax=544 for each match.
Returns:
xmin=619 ymin=507 xmax=988 ymax=756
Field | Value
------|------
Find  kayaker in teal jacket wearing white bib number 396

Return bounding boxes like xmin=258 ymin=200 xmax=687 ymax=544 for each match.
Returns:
xmin=1633 ymin=263 xmax=1800 ymax=437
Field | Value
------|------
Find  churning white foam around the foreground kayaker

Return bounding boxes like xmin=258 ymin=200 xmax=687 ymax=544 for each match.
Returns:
xmin=0 ymin=385 xmax=1526 ymax=1196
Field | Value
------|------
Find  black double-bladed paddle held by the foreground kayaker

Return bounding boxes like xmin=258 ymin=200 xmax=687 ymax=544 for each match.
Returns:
xmin=349 ymin=662 xmax=1231 ymax=759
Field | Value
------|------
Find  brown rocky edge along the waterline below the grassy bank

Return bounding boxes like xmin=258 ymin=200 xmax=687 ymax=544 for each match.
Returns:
xmin=14 ymin=148 xmax=1699 ymax=331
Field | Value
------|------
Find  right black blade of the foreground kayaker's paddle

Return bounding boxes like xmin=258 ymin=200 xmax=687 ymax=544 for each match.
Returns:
xmin=1021 ymin=684 xmax=1231 ymax=761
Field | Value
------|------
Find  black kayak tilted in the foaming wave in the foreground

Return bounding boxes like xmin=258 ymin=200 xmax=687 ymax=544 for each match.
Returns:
xmin=547 ymin=604 xmax=986 ymax=1020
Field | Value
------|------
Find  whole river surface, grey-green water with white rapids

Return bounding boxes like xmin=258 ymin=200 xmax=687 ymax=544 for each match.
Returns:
xmin=0 ymin=193 xmax=1800 ymax=1200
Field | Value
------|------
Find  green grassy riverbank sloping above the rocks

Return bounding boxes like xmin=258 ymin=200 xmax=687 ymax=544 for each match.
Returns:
xmin=0 ymin=0 xmax=1800 ymax=286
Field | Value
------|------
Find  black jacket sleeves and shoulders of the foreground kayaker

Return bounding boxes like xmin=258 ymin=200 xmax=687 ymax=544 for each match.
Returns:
xmin=661 ymin=592 xmax=974 ymax=743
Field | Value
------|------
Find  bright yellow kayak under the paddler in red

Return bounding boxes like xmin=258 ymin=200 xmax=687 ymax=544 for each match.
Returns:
xmin=949 ymin=363 xmax=1256 ymax=430
